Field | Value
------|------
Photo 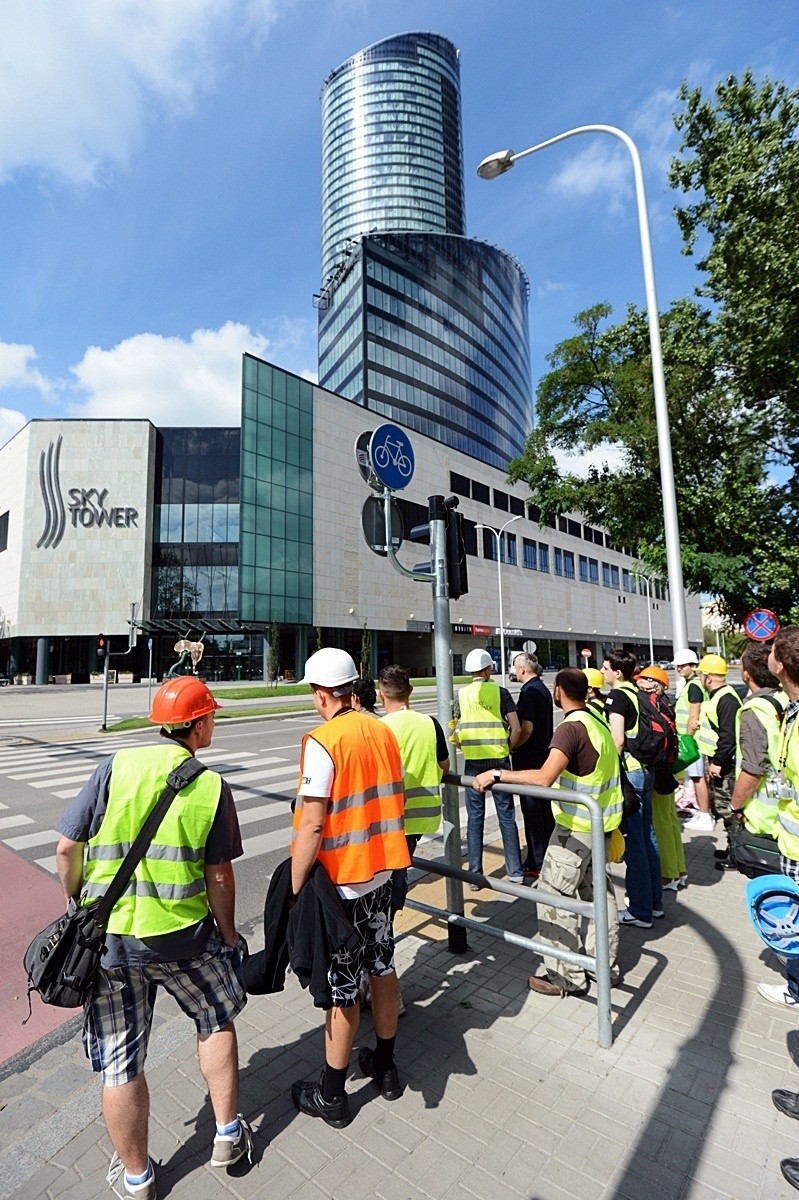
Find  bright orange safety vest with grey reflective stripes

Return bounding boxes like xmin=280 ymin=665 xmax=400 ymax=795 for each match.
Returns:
xmin=292 ymin=712 xmax=410 ymax=884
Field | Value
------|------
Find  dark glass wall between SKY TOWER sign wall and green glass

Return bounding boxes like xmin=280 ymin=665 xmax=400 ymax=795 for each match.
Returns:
xmin=151 ymin=428 xmax=240 ymax=620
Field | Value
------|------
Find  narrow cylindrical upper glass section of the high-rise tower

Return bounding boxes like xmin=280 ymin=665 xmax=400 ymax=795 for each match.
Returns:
xmin=322 ymin=34 xmax=465 ymax=284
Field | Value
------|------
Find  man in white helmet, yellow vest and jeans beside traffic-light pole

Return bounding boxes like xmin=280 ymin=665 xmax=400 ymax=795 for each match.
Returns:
xmin=456 ymin=650 xmax=523 ymax=892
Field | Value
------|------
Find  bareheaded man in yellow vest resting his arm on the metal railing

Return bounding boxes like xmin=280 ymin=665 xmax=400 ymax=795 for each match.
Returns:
xmin=475 ymin=667 xmax=621 ymax=996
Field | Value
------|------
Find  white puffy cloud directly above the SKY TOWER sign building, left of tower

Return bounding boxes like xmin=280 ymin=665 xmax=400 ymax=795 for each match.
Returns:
xmin=68 ymin=320 xmax=270 ymax=426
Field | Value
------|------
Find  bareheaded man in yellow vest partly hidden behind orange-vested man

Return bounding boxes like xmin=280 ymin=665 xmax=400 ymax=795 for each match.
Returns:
xmin=378 ymin=664 xmax=450 ymax=913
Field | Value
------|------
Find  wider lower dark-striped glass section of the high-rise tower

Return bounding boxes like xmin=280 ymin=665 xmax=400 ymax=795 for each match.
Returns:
xmin=319 ymin=233 xmax=533 ymax=469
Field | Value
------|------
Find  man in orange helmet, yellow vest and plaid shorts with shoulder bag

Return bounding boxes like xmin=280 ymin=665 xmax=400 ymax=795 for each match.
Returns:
xmin=55 ymin=676 xmax=252 ymax=1200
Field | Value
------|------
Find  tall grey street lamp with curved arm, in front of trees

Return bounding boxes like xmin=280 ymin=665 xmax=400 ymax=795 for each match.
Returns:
xmin=477 ymin=125 xmax=687 ymax=652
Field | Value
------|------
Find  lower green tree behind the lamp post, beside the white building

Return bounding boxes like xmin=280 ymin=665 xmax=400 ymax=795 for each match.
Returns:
xmin=509 ymin=300 xmax=799 ymax=618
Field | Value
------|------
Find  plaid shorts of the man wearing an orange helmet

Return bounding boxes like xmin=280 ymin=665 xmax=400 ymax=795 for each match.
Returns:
xmin=83 ymin=932 xmax=247 ymax=1087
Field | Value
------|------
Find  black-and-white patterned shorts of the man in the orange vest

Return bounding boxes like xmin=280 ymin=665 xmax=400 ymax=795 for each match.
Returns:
xmin=328 ymin=880 xmax=394 ymax=1008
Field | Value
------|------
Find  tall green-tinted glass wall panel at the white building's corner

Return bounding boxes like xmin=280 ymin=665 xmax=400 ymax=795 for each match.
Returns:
xmin=239 ymin=354 xmax=313 ymax=625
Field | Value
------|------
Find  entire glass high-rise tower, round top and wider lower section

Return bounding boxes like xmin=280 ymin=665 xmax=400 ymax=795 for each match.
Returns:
xmin=316 ymin=34 xmax=531 ymax=469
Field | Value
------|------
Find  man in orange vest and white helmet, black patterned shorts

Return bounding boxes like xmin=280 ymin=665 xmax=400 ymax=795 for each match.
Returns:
xmin=292 ymin=647 xmax=410 ymax=1129
